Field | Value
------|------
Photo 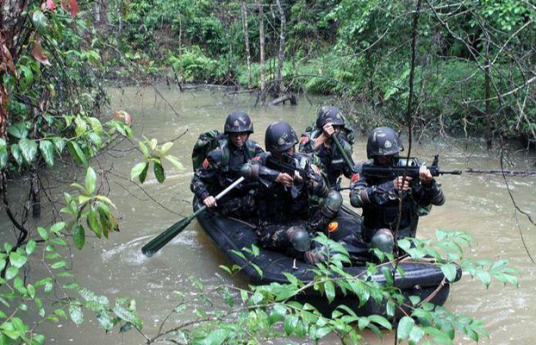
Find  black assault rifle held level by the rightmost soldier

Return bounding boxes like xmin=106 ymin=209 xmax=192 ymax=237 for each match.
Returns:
xmin=362 ymin=155 xmax=462 ymax=182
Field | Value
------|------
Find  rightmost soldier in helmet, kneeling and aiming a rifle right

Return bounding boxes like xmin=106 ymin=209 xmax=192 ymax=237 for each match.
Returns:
xmin=350 ymin=127 xmax=445 ymax=253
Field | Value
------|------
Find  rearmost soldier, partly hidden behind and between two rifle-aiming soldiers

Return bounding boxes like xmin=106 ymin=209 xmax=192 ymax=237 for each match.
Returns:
xmin=299 ymin=106 xmax=354 ymax=189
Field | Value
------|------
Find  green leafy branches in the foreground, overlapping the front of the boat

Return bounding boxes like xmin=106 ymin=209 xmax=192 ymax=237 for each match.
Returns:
xmin=108 ymin=230 xmax=517 ymax=344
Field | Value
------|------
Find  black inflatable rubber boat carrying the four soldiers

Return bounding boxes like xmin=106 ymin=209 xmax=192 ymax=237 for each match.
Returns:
xmin=194 ymin=201 xmax=461 ymax=316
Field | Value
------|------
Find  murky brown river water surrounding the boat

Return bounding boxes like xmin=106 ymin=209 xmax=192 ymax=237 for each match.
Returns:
xmin=2 ymin=86 xmax=536 ymax=345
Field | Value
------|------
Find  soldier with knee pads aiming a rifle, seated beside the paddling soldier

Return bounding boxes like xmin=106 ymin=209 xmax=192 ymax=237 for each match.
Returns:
xmin=242 ymin=121 xmax=342 ymax=263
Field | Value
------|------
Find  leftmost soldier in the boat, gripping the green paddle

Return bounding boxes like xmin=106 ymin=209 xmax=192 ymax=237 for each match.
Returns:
xmin=190 ymin=110 xmax=264 ymax=218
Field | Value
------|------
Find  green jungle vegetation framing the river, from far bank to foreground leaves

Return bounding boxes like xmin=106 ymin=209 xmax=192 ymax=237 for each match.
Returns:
xmin=0 ymin=0 xmax=536 ymax=345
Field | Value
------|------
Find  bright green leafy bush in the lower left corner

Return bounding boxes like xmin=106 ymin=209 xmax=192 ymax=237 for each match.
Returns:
xmin=0 ymin=168 xmax=135 ymax=345
